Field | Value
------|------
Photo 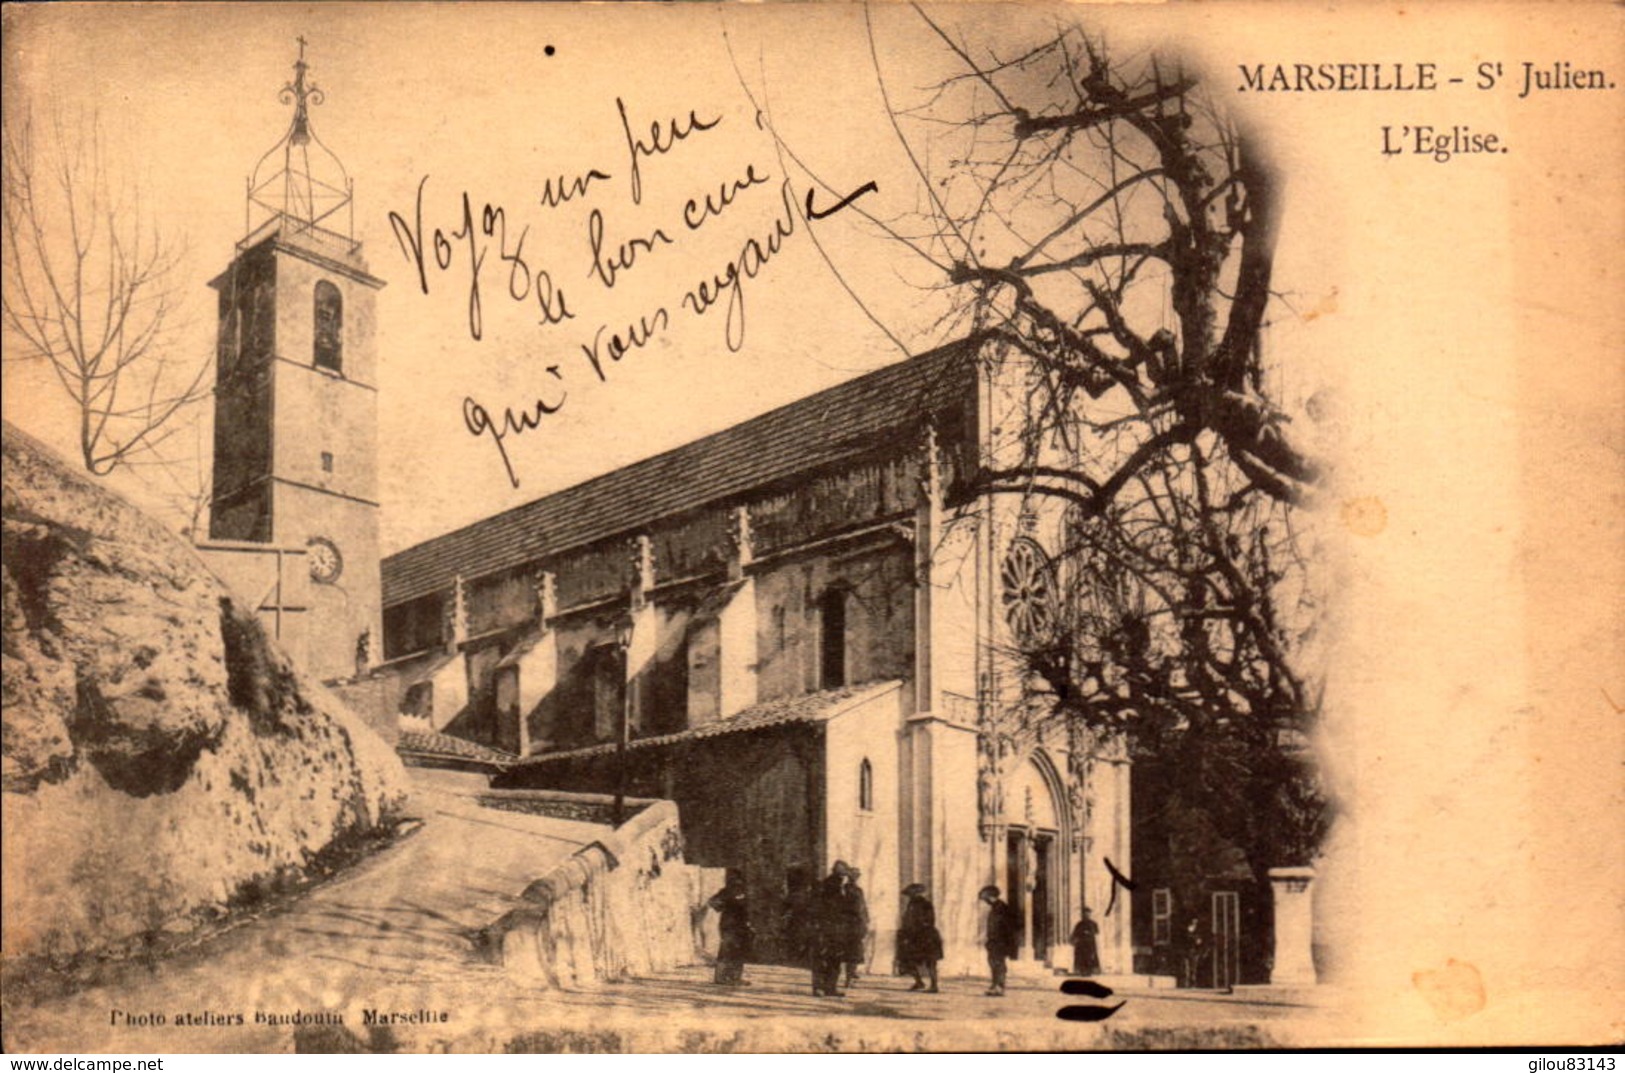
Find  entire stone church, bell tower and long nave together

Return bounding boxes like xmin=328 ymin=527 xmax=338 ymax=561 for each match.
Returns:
xmin=198 ymin=42 xmax=1133 ymax=974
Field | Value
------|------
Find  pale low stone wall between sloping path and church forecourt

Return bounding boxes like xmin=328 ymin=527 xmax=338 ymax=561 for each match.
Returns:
xmin=488 ymin=795 xmax=725 ymax=988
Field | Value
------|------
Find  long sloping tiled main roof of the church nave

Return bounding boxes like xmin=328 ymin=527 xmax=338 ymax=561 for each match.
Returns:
xmin=384 ymin=340 xmax=977 ymax=606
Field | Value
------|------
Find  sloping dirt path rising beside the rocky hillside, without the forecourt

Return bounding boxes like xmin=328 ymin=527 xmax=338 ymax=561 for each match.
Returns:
xmin=5 ymin=772 xmax=600 ymax=1052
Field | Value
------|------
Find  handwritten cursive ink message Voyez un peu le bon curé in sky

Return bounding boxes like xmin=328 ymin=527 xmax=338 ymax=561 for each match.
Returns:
xmin=388 ymin=98 xmax=878 ymax=488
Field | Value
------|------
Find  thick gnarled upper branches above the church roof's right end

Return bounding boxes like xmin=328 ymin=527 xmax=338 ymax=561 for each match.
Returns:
xmin=741 ymin=5 xmax=1316 ymax=514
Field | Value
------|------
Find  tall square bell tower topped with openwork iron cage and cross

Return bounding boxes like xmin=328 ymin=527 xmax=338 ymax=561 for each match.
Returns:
xmin=210 ymin=37 xmax=384 ymax=678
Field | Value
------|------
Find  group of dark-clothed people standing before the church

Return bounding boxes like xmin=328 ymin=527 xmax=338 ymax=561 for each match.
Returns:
xmin=710 ymin=860 xmax=1100 ymax=998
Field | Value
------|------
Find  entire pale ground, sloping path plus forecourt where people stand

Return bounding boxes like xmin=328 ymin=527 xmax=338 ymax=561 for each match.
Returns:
xmin=5 ymin=772 xmax=1345 ymax=1053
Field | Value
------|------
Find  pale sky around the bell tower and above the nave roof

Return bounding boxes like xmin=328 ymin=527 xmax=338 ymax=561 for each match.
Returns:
xmin=7 ymin=5 xmax=1345 ymax=551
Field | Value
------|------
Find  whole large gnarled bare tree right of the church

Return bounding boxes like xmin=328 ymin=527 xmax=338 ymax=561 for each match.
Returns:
xmin=747 ymin=7 xmax=1326 ymax=923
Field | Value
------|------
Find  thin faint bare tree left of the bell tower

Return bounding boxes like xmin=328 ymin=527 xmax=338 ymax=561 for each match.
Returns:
xmin=3 ymin=117 xmax=210 ymax=476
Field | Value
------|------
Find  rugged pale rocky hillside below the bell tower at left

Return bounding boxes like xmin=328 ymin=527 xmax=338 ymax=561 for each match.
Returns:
xmin=0 ymin=426 xmax=406 ymax=964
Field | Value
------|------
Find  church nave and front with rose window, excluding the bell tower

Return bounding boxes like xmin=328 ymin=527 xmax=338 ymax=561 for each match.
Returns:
xmin=382 ymin=340 xmax=1133 ymax=974
